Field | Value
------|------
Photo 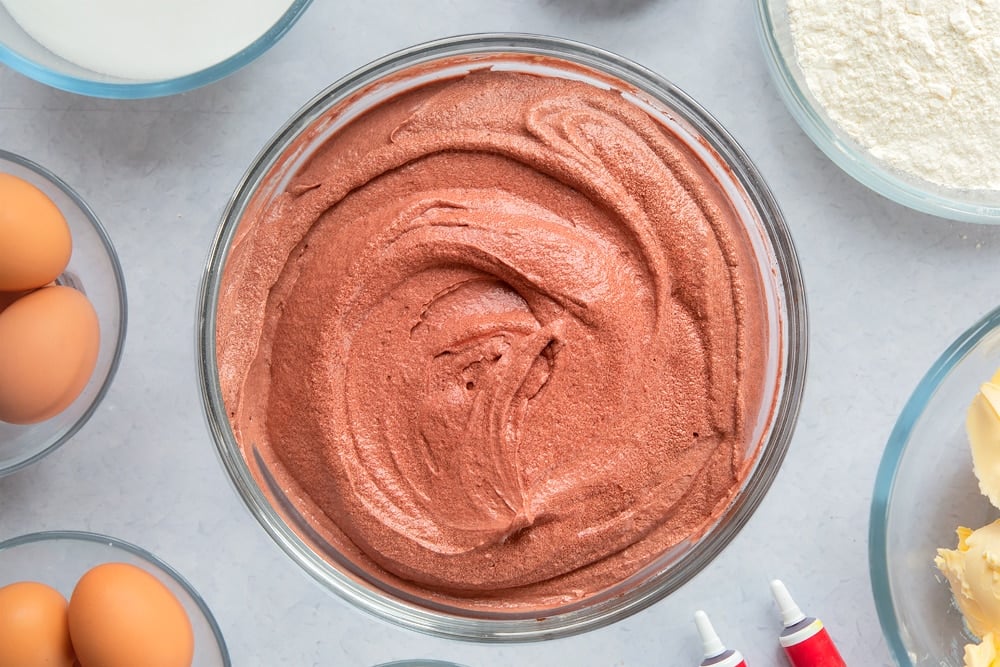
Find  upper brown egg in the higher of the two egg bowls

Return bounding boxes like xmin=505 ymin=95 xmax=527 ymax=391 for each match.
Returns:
xmin=0 ymin=174 xmax=73 ymax=292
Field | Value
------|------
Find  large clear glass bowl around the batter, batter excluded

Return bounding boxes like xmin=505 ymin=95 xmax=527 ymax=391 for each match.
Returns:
xmin=198 ymin=34 xmax=807 ymax=641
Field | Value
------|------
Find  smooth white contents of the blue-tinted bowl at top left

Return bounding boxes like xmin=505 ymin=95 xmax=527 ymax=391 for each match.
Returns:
xmin=0 ymin=0 xmax=291 ymax=79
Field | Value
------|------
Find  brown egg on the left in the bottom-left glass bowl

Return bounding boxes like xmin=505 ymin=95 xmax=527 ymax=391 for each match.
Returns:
xmin=0 ymin=581 xmax=73 ymax=667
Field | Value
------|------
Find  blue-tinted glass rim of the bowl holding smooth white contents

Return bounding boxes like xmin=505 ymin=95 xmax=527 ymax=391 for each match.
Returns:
xmin=0 ymin=0 xmax=313 ymax=100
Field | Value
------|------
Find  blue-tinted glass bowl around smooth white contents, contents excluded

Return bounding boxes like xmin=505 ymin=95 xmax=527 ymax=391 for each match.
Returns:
xmin=0 ymin=0 xmax=312 ymax=99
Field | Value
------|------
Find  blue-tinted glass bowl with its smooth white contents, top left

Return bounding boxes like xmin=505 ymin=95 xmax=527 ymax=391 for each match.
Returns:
xmin=0 ymin=0 xmax=312 ymax=99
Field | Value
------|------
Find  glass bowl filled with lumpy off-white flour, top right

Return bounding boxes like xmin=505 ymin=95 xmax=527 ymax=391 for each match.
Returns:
xmin=756 ymin=0 xmax=1000 ymax=223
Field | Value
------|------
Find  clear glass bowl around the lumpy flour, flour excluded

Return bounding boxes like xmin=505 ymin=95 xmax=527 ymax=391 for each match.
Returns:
xmin=756 ymin=0 xmax=1000 ymax=223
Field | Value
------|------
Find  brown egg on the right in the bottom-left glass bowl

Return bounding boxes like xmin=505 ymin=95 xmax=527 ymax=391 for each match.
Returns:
xmin=69 ymin=563 xmax=194 ymax=667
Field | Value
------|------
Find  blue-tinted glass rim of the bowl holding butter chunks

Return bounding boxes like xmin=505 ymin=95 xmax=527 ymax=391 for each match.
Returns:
xmin=868 ymin=307 xmax=1000 ymax=666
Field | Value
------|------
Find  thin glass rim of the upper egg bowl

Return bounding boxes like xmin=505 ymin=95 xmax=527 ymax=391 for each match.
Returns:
xmin=0 ymin=148 xmax=128 ymax=477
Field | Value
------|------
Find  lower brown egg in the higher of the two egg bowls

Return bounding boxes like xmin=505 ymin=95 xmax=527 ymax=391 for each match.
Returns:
xmin=0 ymin=285 xmax=100 ymax=424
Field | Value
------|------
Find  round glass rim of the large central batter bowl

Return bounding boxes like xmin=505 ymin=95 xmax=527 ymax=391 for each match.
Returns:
xmin=195 ymin=33 xmax=808 ymax=642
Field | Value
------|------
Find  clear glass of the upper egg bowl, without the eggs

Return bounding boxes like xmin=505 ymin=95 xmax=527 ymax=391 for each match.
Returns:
xmin=0 ymin=150 xmax=127 ymax=477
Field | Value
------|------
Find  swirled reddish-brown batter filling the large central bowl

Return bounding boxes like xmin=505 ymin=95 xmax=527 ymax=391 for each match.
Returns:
xmin=218 ymin=71 xmax=766 ymax=608
